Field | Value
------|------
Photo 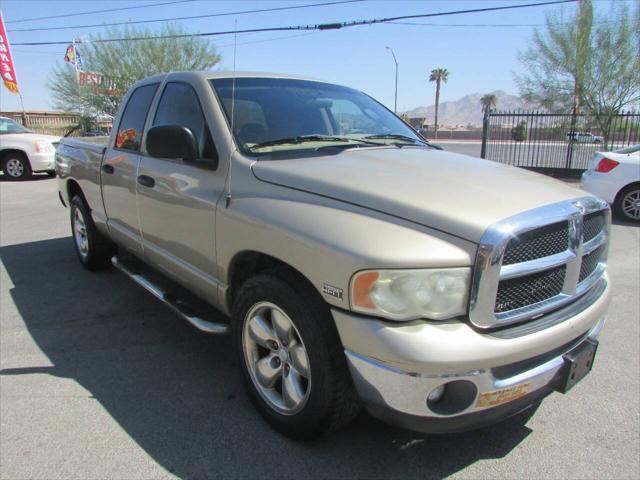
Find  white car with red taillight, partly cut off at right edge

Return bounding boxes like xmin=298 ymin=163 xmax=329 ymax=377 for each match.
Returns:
xmin=582 ymin=144 xmax=640 ymax=222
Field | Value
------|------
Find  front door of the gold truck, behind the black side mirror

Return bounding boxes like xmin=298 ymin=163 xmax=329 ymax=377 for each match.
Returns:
xmin=138 ymin=81 xmax=225 ymax=302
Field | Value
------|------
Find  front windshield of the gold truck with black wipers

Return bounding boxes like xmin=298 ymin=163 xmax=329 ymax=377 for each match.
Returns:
xmin=211 ymin=77 xmax=428 ymax=158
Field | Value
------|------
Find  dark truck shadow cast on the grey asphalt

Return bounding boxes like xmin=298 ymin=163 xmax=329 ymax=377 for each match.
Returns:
xmin=0 ymin=238 xmax=531 ymax=479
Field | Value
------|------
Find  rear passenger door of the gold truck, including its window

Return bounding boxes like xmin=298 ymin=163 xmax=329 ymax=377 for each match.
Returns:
xmin=100 ymin=83 xmax=158 ymax=253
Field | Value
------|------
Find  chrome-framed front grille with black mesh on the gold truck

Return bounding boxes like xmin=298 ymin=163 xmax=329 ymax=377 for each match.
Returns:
xmin=469 ymin=197 xmax=610 ymax=328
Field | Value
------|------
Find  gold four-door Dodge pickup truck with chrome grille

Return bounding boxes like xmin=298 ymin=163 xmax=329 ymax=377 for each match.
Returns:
xmin=56 ymin=72 xmax=610 ymax=438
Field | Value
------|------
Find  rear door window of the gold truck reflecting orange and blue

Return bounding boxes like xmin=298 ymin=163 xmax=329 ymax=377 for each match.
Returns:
xmin=116 ymin=83 xmax=158 ymax=152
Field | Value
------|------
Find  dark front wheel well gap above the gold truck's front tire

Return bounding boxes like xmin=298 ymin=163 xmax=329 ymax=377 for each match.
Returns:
xmin=227 ymin=251 xmax=324 ymax=307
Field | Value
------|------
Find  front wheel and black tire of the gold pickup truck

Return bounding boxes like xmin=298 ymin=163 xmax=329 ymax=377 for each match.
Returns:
xmin=233 ymin=272 xmax=361 ymax=440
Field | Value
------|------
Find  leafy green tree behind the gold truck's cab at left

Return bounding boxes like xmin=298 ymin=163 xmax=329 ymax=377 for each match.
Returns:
xmin=47 ymin=25 xmax=220 ymax=122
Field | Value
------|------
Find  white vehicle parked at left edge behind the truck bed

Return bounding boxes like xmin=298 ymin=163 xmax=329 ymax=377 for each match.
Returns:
xmin=0 ymin=117 xmax=60 ymax=180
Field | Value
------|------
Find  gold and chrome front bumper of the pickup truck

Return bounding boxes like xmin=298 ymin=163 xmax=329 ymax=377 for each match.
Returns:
xmin=333 ymin=276 xmax=610 ymax=433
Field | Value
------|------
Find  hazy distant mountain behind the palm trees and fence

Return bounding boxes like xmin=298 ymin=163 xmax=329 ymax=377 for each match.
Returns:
xmin=404 ymin=90 xmax=532 ymax=127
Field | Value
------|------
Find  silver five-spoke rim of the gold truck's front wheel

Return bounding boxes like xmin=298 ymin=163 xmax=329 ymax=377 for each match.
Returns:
xmin=242 ymin=302 xmax=311 ymax=415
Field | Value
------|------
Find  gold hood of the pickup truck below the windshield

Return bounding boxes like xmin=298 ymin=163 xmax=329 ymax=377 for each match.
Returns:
xmin=252 ymin=147 xmax=585 ymax=242
